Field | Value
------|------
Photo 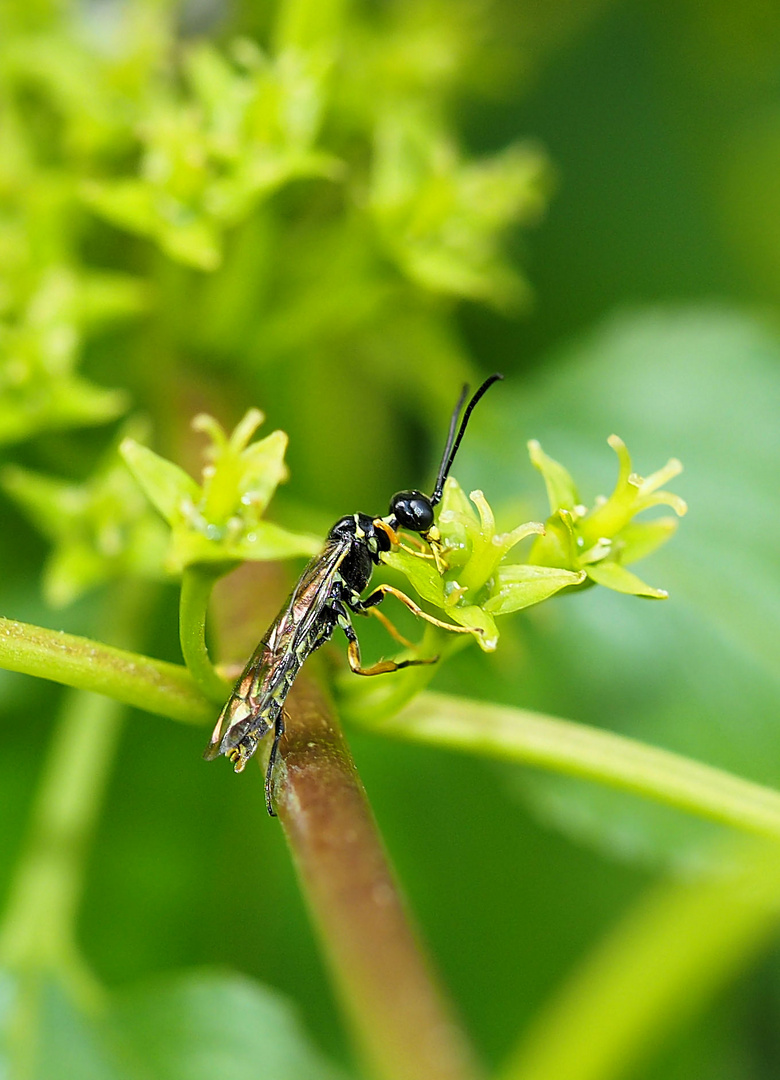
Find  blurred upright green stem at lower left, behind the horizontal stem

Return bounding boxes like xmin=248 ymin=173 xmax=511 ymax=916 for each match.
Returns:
xmin=0 ymin=585 xmax=157 ymax=1080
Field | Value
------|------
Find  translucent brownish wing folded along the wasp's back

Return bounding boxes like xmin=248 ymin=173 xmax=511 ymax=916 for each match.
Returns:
xmin=203 ymin=540 xmax=349 ymax=761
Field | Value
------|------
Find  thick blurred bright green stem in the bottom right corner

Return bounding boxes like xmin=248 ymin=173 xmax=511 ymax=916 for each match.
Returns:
xmin=499 ymin=841 xmax=780 ymax=1080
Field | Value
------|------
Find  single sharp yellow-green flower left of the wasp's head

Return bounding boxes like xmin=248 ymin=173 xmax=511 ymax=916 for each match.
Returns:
xmin=120 ymin=408 xmax=321 ymax=573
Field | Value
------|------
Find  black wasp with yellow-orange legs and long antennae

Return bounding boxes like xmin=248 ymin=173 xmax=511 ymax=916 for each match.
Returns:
xmin=203 ymin=374 xmax=503 ymax=816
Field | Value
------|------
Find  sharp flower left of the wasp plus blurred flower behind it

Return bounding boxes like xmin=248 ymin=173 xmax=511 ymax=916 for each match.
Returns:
xmin=0 ymin=409 xmax=321 ymax=607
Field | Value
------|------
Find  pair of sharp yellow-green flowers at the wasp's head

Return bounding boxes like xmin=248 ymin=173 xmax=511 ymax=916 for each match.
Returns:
xmin=384 ymin=435 xmax=687 ymax=651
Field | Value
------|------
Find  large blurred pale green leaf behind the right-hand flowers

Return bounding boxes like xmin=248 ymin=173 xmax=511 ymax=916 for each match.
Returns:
xmin=459 ymin=307 xmax=780 ymax=864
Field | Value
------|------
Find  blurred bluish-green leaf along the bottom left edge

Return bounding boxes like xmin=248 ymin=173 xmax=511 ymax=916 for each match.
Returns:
xmin=0 ymin=971 xmax=345 ymax=1080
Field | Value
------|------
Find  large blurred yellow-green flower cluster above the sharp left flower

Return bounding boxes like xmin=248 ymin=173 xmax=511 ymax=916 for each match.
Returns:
xmin=82 ymin=39 xmax=341 ymax=270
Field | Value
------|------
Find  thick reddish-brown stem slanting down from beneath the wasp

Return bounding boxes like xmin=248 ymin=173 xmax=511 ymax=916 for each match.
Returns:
xmin=277 ymin=661 xmax=481 ymax=1080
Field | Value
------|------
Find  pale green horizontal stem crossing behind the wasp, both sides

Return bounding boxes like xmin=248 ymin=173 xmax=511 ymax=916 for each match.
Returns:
xmin=7 ymin=619 xmax=780 ymax=851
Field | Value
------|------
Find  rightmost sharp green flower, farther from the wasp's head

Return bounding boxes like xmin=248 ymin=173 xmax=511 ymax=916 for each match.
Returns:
xmin=528 ymin=435 xmax=688 ymax=599
